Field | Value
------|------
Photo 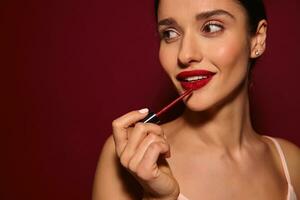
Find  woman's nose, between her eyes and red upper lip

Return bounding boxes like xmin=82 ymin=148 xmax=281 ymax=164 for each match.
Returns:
xmin=178 ymin=33 xmax=202 ymax=68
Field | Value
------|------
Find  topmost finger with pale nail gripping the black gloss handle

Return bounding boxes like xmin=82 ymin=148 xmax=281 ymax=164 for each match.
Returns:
xmin=112 ymin=109 xmax=149 ymax=155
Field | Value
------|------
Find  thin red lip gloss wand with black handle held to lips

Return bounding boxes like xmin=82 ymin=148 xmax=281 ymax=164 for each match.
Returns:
xmin=141 ymin=89 xmax=193 ymax=124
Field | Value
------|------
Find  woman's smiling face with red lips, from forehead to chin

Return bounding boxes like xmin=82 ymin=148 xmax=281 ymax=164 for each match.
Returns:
xmin=158 ymin=0 xmax=255 ymax=111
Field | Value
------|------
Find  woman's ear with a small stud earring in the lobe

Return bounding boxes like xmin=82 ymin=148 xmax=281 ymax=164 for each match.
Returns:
xmin=250 ymin=19 xmax=268 ymax=58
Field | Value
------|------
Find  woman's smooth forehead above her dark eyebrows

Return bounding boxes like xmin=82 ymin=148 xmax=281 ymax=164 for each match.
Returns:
xmin=158 ymin=0 xmax=246 ymax=20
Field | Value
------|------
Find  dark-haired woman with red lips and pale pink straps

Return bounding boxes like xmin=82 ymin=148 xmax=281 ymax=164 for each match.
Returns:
xmin=93 ymin=0 xmax=300 ymax=200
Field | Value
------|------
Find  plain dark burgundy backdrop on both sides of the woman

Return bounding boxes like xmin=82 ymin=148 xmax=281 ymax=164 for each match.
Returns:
xmin=0 ymin=0 xmax=300 ymax=200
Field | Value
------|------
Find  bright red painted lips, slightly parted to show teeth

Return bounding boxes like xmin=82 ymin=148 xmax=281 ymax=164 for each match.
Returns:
xmin=176 ymin=70 xmax=216 ymax=90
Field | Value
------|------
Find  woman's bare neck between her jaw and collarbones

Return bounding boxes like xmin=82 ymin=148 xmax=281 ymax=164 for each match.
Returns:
xmin=182 ymin=81 xmax=255 ymax=150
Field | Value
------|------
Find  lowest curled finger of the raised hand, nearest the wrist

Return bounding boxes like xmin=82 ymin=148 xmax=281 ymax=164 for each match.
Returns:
xmin=136 ymin=142 xmax=170 ymax=181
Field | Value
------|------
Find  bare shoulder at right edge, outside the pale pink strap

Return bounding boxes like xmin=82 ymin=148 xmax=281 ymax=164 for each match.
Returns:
xmin=276 ymin=138 xmax=300 ymax=197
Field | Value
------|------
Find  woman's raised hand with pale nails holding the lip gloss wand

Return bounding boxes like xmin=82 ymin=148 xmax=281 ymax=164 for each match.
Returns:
xmin=112 ymin=109 xmax=179 ymax=200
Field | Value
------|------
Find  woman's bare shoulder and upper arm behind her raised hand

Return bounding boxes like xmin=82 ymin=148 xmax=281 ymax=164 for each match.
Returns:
xmin=92 ymin=136 xmax=141 ymax=200
